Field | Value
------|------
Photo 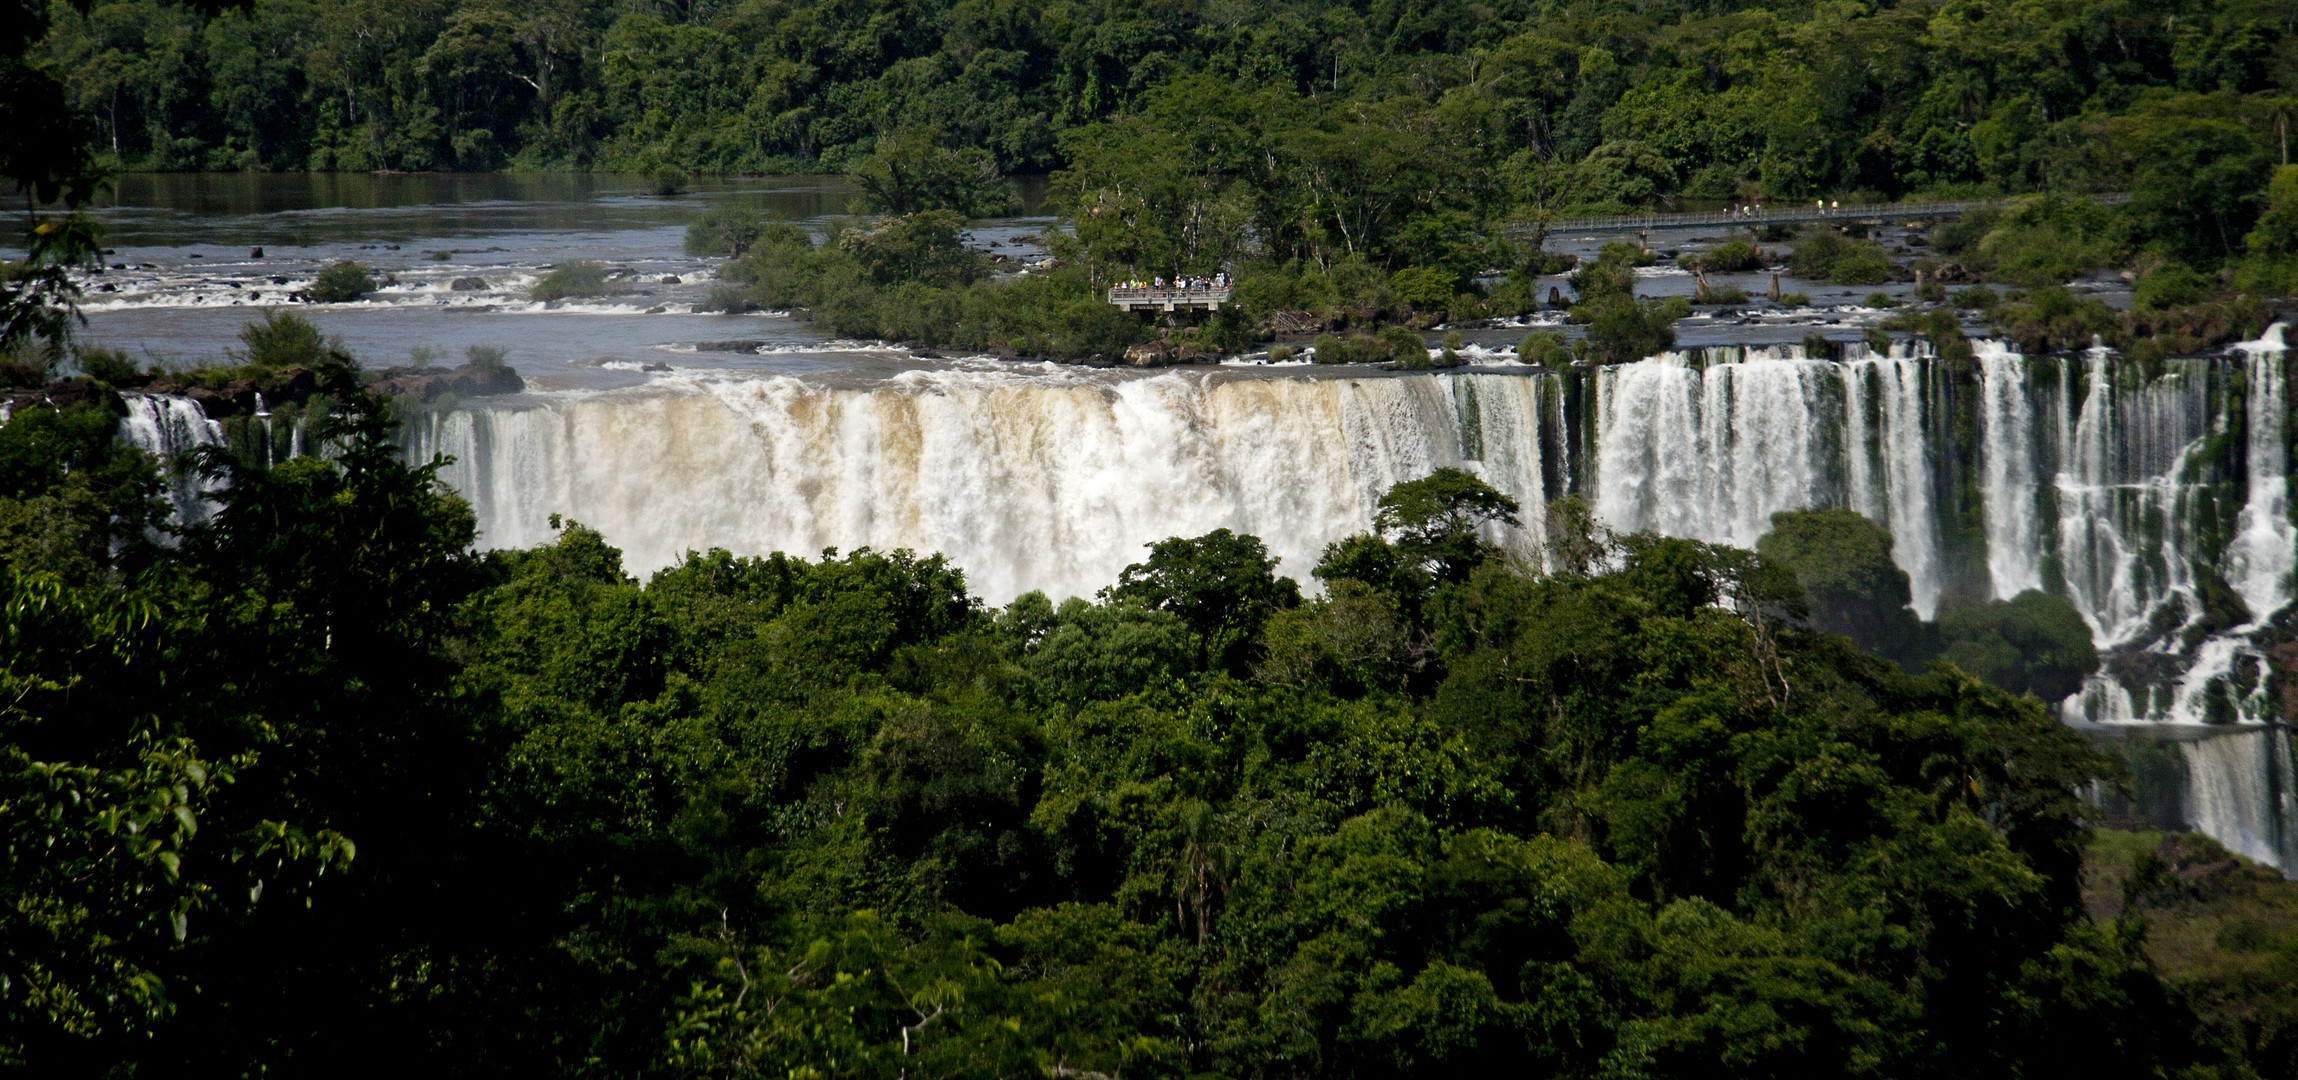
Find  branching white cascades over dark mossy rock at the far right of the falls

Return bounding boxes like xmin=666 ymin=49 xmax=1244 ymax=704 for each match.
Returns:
xmin=1979 ymin=326 xmax=2298 ymax=724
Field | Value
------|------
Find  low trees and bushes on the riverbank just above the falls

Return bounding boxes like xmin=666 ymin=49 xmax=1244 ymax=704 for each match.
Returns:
xmin=687 ymin=125 xmax=2298 ymax=363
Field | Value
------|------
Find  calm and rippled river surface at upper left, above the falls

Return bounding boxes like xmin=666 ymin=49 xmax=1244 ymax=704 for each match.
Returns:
xmin=69 ymin=175 xmax=1050 ymax=388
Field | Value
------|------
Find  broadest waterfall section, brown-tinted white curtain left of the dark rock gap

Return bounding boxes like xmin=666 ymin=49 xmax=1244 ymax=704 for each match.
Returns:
xmin=409 ymin=372 xmax=1542 ymax=602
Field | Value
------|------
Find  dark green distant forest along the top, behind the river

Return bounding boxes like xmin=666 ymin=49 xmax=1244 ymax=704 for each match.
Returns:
xmin=34 ymin=0 xmax=2298 ymax=212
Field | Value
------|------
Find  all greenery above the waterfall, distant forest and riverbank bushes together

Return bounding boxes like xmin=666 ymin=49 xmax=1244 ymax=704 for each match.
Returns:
xmin=7 ymin=0 xmax=2298 ymax=361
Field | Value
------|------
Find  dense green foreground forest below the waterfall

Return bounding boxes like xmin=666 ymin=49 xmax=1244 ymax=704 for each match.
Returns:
xmin=0 ymin=358 xmax=2287 ymax=1078
